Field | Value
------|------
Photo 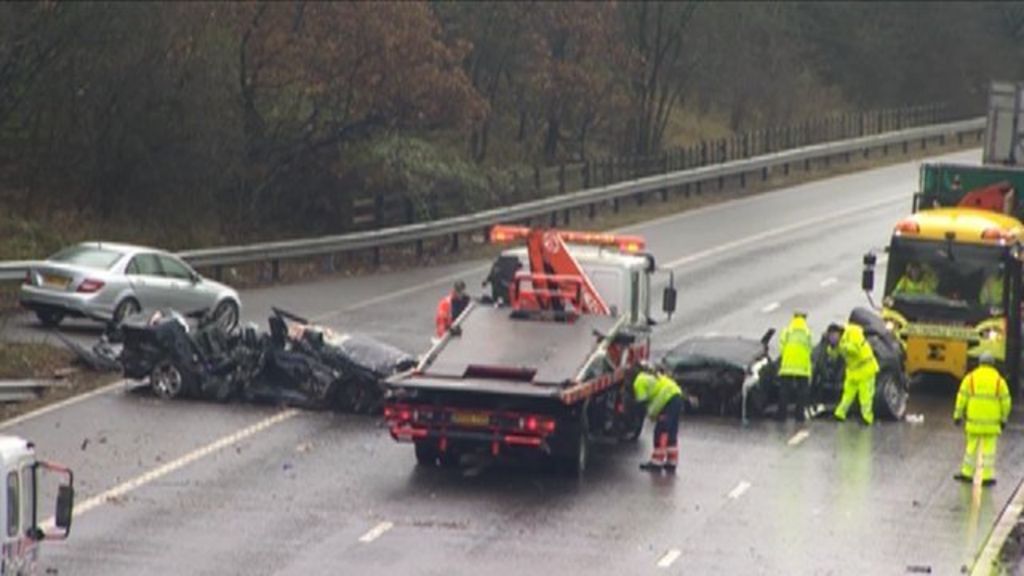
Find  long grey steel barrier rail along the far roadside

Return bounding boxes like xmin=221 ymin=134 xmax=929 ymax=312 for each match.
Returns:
xmin=0 ymin=118 xmax=985 ymax=281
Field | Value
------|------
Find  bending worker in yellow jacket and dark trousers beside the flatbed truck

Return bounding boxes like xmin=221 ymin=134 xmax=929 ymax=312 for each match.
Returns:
xmin=633 ymin=368 xmax=683 ymax=472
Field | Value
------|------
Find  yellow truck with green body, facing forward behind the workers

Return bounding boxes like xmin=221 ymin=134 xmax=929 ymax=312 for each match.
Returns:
xmin=864 ymin=159 xmax=1024 ymax=388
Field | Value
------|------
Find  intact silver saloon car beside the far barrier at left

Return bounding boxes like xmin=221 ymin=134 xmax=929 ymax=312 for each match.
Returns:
xmin=18 ymin=242 xmax=241 ymax=328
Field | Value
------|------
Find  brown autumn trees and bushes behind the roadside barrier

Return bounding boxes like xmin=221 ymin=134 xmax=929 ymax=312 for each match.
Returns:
xmin=0 ymin=1 xmax=1024 ymax=247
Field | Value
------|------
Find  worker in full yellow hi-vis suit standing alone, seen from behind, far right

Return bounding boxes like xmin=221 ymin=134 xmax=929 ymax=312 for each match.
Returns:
xmin=953 ymin=352 xmax=1012 ymax=486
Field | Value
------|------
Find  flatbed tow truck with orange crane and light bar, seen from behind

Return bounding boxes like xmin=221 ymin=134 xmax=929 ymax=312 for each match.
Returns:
xmin=384 ymin=225 xmax=676 ymax=474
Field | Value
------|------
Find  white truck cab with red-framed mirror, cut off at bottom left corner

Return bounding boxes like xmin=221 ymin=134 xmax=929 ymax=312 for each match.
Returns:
xmin=0 ymin=435 xmax=75 ymax=576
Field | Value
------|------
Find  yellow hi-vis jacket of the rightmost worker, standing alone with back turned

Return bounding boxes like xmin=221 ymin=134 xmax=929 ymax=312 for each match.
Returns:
xmin=953 ymin=365 xmax=1012 ymax=435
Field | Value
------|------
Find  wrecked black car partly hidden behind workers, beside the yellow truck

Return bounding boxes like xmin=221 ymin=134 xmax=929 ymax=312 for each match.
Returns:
xmin=659 ymin=307 xmax=909 ymax=420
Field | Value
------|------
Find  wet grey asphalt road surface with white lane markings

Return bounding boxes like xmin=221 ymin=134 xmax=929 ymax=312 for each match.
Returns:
xmin=6 ymin=148 xmax=1024 ymax=575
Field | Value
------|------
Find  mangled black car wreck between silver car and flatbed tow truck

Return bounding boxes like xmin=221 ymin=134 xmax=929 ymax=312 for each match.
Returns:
xmin=62 ymin=308 xmax=416 ymax=413
